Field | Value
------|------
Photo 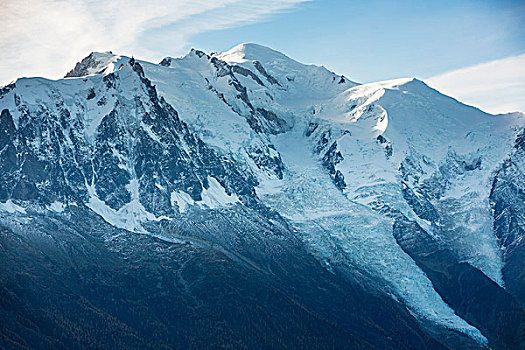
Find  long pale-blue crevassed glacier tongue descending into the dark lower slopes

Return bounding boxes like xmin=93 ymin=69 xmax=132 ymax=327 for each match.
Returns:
xmin=257 ymin=119 xmax=487 ymax=343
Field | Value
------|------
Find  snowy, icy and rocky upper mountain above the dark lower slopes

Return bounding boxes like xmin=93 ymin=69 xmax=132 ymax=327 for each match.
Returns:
xmin=0 ymin=44 xmax=525 ymax=347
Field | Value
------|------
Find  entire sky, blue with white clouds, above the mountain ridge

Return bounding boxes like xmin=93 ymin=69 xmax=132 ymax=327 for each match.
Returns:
xmin=0 ymin=0 xmax=525 ymax=111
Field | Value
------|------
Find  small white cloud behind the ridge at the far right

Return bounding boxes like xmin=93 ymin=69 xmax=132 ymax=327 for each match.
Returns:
xmin=426 ymin=54 xmax=525 ymax=113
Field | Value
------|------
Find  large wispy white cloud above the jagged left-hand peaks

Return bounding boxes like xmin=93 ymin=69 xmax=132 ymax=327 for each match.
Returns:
xmin=0 ymin=0 xmax=308 ymax=85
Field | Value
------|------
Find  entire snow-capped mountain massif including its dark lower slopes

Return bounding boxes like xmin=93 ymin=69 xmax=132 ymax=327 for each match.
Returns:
xmin=0 ymin=44 xmax=525 ymax=349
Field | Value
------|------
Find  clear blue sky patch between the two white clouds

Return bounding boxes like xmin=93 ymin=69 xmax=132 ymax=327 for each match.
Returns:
xmin=188 ymin=0 xmax=525 ymax=82
